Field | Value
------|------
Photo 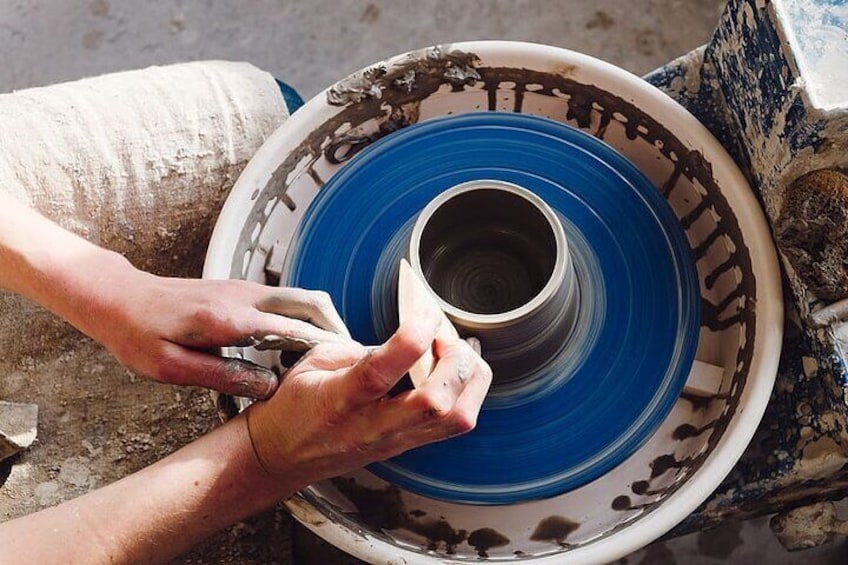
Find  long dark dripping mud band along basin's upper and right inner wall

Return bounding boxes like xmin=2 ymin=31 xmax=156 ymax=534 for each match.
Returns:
xmin=237 ymin=41 xmax=757 ymax=533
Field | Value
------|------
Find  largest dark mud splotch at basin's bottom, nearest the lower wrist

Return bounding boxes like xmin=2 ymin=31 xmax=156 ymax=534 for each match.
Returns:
xmin=332 ymin=477 xmax=468 ymax=555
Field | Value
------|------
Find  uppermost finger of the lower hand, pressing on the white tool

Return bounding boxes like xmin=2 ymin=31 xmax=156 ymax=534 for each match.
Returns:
xmin=339 ymin=311 xmax=441 ymax=406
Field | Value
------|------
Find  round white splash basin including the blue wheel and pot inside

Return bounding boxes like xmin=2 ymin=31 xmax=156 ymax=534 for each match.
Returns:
xmin=205 ymin=42 xmax=781 ymax=563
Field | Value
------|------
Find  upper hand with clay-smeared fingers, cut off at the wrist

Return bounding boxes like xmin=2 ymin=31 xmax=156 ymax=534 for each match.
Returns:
xmin=84 ymin=267 xmax=350 ymax=398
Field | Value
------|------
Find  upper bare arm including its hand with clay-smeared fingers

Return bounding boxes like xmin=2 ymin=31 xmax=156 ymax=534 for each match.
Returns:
xmin=0 ymin=190 xmax=349 ymax=398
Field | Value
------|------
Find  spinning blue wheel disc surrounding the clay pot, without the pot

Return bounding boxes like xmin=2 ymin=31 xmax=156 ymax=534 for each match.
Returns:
xmin=286 ymin=113 xmax=700 ymax=504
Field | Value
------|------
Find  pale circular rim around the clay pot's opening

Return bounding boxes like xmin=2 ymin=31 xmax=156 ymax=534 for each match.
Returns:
xmin=409 ymin=179 xmax=570 ymax=328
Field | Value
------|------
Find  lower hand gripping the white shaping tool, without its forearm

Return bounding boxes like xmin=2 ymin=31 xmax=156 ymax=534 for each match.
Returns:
xmin=247 ymin=313 xmax=492 ymax=487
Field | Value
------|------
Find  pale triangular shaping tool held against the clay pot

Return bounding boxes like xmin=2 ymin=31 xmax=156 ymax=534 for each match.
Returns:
xmin=398 ymin=259 xmax=459 ymax=388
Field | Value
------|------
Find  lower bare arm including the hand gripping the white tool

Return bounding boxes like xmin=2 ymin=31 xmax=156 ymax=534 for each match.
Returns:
xmin=0 ymin=308 xmax=491 ymax=563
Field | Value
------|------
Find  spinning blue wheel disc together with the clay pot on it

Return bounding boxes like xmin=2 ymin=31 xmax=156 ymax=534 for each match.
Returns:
xmin=285 ymin=112 xmax=699 ymax=504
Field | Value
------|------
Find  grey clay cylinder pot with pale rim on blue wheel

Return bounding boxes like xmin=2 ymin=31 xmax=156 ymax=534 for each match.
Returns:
xmin=409 ymin=180 xmax=579 ymax=384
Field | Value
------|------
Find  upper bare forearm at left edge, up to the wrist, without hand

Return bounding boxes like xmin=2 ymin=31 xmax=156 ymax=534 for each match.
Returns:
xmin=0 ymin=190 xmax=135 ymax=338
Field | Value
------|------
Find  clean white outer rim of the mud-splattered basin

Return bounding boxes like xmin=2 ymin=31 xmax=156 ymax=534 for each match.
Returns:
xmin=203 ymin=41 xmax=783 ymax=565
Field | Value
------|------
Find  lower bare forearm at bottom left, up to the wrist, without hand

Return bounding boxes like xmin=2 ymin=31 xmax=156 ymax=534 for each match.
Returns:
xmin=0 ymin=416 xmax=304 ymax=563
